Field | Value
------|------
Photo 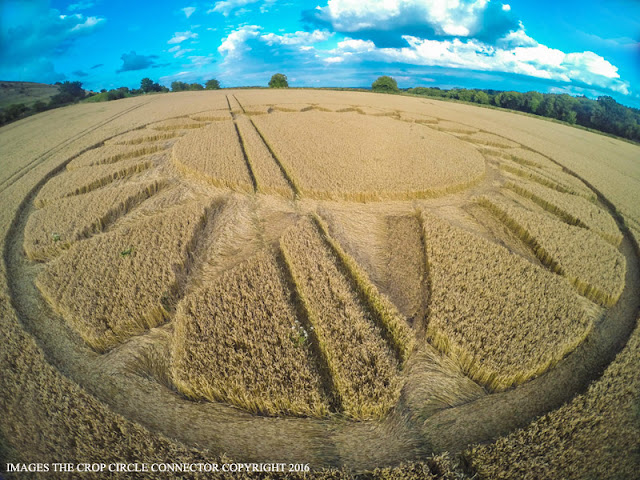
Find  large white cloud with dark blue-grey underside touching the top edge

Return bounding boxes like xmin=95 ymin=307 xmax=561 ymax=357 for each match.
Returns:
xmin=303 ymin=0 xmax=518 ymax=47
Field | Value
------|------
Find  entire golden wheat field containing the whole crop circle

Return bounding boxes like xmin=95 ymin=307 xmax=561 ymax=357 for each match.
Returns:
xmin=0 ymin=89 xmax=640 ymax=479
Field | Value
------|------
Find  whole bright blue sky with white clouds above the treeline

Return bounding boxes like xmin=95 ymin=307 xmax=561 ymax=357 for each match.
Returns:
xmin=0 ymin=0 xmax=640 ymax=107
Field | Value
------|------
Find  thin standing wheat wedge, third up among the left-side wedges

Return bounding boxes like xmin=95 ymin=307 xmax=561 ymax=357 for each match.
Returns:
xmin=34 ymin=157 xmax=156 ymax=208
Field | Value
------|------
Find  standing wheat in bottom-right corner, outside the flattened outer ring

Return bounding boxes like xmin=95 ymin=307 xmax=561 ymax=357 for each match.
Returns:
xmin=467 ymin=319 xmax=640 ymax=480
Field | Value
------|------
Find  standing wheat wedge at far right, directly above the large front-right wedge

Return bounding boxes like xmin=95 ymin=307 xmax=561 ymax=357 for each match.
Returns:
xmin=479 ymin=197 xmax=627 ymax=306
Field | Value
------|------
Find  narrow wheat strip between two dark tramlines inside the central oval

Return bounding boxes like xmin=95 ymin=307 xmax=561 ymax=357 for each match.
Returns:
xmin=236 ymin=115 xmax=293 ymax=197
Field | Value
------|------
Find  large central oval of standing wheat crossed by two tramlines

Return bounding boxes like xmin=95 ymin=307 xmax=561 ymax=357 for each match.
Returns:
xmin=173 ymin=111 xmax=485 ymax=201
